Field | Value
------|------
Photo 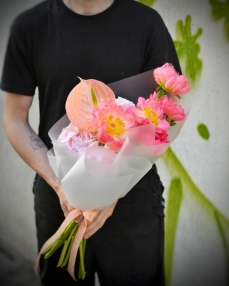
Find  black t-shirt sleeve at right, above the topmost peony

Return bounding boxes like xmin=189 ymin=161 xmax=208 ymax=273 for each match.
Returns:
xmin=143 ymin=10 xmax=182 ymax=74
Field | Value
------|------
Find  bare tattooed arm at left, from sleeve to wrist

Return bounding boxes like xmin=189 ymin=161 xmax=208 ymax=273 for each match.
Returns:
xmin=3 ymin=93 xmax=72 ymax=216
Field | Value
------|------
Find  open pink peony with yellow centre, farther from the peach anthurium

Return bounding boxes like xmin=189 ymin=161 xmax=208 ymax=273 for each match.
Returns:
xmin=132 ymin=92 xmax=170 ymax=133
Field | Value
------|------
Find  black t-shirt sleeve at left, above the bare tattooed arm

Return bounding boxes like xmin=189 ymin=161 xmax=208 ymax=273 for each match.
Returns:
xmin=0 ymin=14 xmax=37 ymax=96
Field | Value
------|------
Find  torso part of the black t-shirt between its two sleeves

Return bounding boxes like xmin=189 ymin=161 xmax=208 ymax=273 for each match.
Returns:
xmin=19 ymin=0 xmax=165 ymax=148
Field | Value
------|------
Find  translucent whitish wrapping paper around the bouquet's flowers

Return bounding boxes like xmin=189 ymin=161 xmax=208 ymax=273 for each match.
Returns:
xmin=48 ymin=71 xmax=190 ymax=210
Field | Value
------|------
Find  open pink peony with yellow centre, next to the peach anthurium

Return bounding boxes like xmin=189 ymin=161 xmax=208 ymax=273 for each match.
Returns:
xmin=97 ymin=104 xmax=135 ymax=151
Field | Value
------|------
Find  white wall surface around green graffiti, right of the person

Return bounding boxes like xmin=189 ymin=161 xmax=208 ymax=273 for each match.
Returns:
xmin=153 ymin=0 xmax=229 ymax=286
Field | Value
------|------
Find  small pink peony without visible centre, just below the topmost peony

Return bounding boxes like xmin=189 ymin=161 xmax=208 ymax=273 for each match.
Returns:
xmin=159 ymin=95 xmax=186 ymax=121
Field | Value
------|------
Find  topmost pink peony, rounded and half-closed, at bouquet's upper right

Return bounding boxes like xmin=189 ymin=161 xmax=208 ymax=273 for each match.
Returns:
xmin=153 ymin=63 xmax=190 ymax=95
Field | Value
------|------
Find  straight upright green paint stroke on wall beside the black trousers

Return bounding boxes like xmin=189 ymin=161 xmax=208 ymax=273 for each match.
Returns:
xmin=165 ymin=178 xmax=183 ymax=285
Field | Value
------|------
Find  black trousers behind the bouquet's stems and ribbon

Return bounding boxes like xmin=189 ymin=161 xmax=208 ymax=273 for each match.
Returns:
xmin=34 ymin=165 xmax=164 ymax=286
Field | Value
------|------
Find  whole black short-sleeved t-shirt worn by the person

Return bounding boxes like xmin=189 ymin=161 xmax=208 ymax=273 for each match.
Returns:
xmin=1 ymin=0 xmax=180 ymax=148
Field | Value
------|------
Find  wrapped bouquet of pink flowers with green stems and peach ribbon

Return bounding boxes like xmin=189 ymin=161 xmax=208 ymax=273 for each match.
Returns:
xmin=36 ymin=63 xmax=190 ymax=279
